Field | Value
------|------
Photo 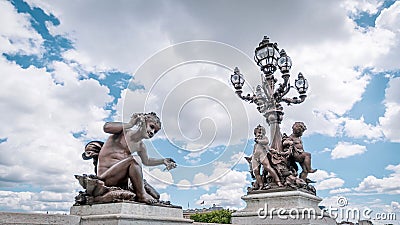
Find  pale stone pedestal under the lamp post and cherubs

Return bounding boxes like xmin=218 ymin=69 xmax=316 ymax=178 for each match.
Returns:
xmin=232 ymin=191 xmax=336 ymax=225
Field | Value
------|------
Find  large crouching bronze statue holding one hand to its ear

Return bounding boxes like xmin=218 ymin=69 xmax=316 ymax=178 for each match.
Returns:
xmin=75 ymin=112 xmax=176 ymax=204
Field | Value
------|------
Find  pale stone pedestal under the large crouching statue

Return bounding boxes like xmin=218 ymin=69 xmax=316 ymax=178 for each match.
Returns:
xmin=70 ymin=202 xmax=193 ymax=225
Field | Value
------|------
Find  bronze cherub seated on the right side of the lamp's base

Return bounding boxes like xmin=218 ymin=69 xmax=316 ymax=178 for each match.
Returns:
xmin=282 ymin=122 xmax=317 ymax=183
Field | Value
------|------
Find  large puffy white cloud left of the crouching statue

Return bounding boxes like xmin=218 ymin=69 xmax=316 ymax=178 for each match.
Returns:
xmin=0 ymin=58 xmax=111 ymax=191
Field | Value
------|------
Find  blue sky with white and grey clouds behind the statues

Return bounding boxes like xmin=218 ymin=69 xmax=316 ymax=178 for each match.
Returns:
xmin=0 ymin=0 xmax=400 ymax=224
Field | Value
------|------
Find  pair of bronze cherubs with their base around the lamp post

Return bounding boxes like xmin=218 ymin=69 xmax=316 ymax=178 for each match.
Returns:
xmin=245 ymin=122 xmax=316 ymax=194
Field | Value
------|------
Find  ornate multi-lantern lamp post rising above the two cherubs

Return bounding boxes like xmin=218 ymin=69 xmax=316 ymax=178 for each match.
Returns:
xmin=231 ymin=36 xmax=308 ymax=151
